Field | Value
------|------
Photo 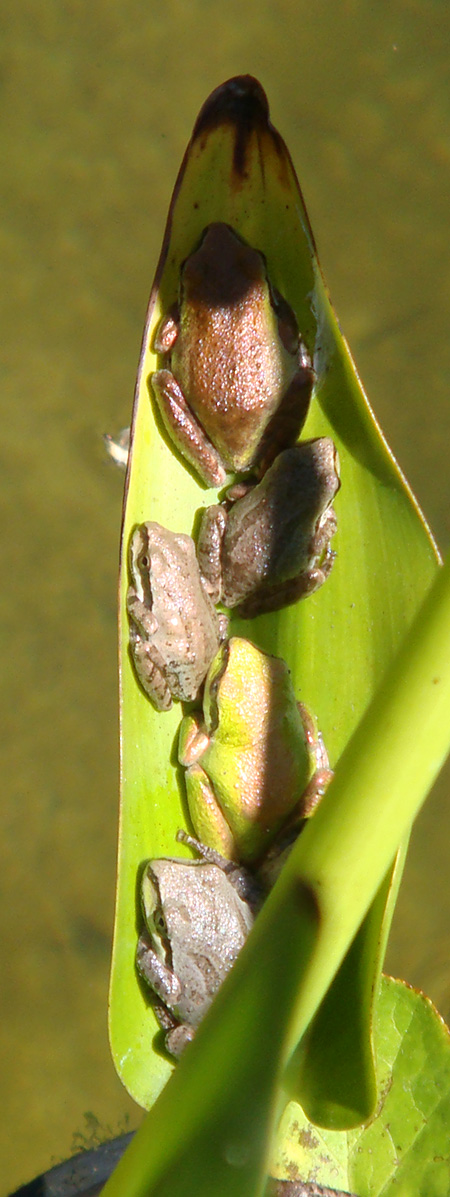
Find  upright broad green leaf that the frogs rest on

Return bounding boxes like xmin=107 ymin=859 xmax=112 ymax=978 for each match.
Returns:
xmin=110 ymin=78 xmax=437 ymax=1120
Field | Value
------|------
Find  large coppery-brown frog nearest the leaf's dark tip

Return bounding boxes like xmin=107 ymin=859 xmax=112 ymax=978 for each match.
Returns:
xmin=148 ymin=221 xmax=315 ymax=487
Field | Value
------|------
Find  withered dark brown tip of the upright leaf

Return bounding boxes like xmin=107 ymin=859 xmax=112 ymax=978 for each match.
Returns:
xmin=193 ymin=75 xmax=272 ymax=175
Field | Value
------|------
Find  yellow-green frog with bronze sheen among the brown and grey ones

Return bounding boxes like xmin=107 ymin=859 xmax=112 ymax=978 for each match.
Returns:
xmin=178 ymin=636 xmax=333 ymax=866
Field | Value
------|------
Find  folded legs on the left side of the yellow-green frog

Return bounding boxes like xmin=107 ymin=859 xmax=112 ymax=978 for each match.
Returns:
xmin=178 ymin=715 xmax=237 ymax=859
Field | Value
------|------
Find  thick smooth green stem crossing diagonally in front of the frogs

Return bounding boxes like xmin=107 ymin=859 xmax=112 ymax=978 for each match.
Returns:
xmin=104 ymin=548 xmax=450 ymax=1197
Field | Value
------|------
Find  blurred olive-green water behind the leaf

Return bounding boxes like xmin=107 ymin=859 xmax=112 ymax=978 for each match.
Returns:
xmin=0 ymin=0 xmax=450 ymax=1197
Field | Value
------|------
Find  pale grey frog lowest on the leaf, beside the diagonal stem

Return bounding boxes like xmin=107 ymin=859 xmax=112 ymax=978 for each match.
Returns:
xmin=136 ymin=831 xmax=259 ymax=1058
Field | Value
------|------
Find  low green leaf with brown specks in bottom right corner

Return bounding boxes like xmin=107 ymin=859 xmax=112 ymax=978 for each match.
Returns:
xmin=270 ymin=977 xmax=450 ymax=1197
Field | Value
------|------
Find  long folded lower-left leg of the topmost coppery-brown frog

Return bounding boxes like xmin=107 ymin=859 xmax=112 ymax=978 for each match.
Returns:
xmin=150 ymin=370 xmax=226 ymax=486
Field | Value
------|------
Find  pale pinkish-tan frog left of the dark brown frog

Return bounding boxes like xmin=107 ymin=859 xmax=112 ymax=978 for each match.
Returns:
xmin=127 ymin=521 xmax=227 ymax=711
